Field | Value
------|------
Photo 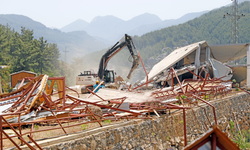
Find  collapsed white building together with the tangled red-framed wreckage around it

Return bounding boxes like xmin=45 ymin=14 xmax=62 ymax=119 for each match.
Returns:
xmin=0 ymin=41 xmax=249 ymax=149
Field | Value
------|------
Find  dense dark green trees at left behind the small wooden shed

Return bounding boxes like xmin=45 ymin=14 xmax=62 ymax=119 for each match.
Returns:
xmin=0 ymin=25 xmax=74 ymax=91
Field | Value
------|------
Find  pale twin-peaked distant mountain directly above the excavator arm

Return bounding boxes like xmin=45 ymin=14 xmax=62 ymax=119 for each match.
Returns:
xmin=78 ymin=13 xmax=161 ymax=43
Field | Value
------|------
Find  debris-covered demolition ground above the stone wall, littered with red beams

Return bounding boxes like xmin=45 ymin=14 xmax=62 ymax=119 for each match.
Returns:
xmin=1 ymin=71 xmax=246 ymax=149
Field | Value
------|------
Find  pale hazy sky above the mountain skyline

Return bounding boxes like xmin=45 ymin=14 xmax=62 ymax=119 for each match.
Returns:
xmin=0 ymin=0 xmax=231 ymax=28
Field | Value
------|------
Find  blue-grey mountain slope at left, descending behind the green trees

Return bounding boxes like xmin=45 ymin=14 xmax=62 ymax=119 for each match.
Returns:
xmin=0 ymin=15 xmax=108 ymax=60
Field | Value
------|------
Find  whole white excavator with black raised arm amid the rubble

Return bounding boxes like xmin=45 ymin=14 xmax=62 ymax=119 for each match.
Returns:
xmin=76 ymin=34 xmax=140 ymax=94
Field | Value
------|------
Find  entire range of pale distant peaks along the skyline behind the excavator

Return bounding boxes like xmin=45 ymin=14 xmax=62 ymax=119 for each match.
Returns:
xmin=61 ymin=11 xmax=207 ymax=44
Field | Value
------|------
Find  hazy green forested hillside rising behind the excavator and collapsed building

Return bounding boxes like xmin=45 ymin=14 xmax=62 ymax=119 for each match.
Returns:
xmin=74 ymin=2 xmax=250 ymax=81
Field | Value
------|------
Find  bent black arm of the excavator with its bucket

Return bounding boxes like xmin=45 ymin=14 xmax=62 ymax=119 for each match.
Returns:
xmin=98 ymin=34 xmax=140 ymax=80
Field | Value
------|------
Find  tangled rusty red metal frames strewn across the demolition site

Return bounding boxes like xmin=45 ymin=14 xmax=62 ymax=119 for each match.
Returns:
xmin=0 ymin=66 xmax=240 ymax=149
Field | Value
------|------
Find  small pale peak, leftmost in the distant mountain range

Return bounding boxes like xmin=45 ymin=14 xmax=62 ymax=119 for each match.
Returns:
xmin=61 ymin=19 xmax=89 ymax=32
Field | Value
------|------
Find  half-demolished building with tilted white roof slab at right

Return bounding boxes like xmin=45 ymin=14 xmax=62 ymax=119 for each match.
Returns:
xmin=143 ymin=41 xmax=249 ymax=86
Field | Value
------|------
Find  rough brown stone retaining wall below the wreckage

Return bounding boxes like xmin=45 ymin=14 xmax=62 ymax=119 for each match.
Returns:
xmin=43 ymin=93 xmax=250 ymax=150
